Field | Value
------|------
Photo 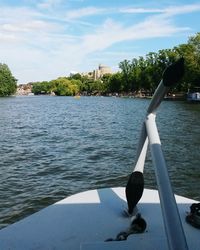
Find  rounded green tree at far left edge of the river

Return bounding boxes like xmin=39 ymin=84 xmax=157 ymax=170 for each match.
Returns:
xmin=0 ymin=63 xmax=17 ymax=96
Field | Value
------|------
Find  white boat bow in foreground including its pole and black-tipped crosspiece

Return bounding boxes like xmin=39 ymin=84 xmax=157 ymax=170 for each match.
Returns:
xmin=0 ymin=58 xmax=200 ymax=250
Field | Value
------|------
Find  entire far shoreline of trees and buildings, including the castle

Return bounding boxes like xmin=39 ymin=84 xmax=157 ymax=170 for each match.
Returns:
xmin=0 ymin=32 xmax=200 ymax=99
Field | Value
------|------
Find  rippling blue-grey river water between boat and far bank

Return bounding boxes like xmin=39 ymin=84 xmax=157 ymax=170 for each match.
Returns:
xmin=0 ymin=96 xmax=200 ymax=228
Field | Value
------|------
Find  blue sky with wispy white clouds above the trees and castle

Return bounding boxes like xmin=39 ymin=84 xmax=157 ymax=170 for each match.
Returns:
xmin=0 ymin=0 xmax=200 ymax=84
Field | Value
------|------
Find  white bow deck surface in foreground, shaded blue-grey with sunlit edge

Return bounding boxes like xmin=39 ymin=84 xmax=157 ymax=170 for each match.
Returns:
xmin=0 ymin=188 xmax=200 ymax=250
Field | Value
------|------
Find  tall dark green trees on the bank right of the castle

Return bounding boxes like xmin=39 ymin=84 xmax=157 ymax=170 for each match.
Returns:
xmin=117 ymin=33 xmax=200 ymax=92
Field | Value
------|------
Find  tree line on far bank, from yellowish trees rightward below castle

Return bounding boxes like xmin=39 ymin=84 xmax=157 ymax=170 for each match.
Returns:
xmin=32 ymin=33 xmax=200 ymax=95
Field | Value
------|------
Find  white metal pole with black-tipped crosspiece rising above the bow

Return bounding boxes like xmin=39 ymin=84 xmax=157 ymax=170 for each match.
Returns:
xmin=126 ymin=58 xmax=188 ymax=250
